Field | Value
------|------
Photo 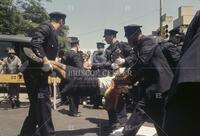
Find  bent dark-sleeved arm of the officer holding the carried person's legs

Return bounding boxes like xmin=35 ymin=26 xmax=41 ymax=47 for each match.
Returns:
xmin=30 ymin=24 xmax=51 ymax=63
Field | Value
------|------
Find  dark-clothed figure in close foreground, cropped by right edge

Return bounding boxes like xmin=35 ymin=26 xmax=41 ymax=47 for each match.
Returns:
xmin=164 ymin=11 xmax=200 ymax=136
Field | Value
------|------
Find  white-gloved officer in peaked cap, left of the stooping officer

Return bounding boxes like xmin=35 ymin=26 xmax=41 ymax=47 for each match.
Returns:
xmin=104 ymin=29 xmax=133 ymax=129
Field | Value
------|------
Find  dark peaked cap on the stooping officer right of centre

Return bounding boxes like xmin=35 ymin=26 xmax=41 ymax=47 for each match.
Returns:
xmin=124 ymin=24 xmax=142 ymax=37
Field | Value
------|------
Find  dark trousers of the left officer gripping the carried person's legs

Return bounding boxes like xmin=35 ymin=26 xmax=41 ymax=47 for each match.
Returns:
xmin=20 ymin=70 xmax=55 ymax=136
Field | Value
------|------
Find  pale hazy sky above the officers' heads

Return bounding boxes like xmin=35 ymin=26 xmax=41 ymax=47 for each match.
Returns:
xmin=43 ymin=0 xmax=200 ymax=50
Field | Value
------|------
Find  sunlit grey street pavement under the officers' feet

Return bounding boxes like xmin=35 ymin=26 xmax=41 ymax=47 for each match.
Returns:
xmin=0 ymin=94 xmax=156 ymax=136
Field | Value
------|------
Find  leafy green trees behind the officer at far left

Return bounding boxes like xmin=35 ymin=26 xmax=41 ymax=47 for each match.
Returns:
xmin=0 ymin=0 xmax=69 ymax=50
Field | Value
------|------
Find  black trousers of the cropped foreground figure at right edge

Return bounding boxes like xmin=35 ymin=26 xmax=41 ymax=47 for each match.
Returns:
xmin=163 ymin=83 xmax=200 ymax=136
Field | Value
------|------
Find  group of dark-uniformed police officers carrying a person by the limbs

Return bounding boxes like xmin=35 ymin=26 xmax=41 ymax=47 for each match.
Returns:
xmin=8 ymin=11 xmax=200 ymax=136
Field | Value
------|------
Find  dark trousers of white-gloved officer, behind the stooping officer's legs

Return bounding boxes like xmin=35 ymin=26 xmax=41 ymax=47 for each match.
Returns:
xmin=108 ymin=95 xmax=127 ymax=125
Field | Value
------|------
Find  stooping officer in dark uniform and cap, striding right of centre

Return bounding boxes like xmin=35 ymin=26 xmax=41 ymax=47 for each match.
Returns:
xmin=119 ymin=25 xmax=173 ymax=136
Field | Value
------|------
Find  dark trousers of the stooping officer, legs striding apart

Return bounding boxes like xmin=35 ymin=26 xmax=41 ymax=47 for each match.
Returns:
xmin=123 ymin=95 xmax=167 ymax=136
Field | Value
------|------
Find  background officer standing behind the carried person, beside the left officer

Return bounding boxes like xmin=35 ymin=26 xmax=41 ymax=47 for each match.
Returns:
xmin=62 ymin=37 xmax=83 ymax=117
